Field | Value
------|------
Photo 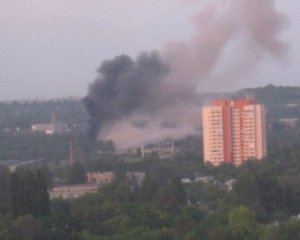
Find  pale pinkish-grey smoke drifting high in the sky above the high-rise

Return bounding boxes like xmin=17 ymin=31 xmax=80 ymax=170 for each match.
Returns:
xmin=163 ymin=0 xmax=287 ymax=91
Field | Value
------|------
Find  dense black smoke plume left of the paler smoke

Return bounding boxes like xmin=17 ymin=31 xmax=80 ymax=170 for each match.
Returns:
xmin=83 ymin=52 xmax=169 ymax=140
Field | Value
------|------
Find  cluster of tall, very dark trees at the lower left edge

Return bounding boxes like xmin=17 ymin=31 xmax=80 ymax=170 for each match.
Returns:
xmin=0 ymin=167 xmax=50 ymax=217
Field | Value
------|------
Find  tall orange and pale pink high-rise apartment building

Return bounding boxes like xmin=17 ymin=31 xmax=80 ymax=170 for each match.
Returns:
xmin=202 ymin=99 xmax=267 ymax=166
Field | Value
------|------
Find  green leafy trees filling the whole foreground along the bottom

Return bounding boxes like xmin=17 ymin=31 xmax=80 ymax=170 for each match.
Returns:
xmin=0 ymin=154 xmax=300 ymax=240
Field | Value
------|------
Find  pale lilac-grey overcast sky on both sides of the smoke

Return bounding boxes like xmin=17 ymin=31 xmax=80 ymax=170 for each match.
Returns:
xmin=0 ymin=0 xmax=300 ymax=100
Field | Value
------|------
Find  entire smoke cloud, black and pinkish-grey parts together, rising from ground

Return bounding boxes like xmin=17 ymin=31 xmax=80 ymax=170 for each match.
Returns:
xmin=84 ymin=0 xmax=287 ymax=147
